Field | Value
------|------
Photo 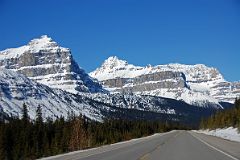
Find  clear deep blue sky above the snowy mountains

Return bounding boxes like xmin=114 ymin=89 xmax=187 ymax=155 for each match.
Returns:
xmin=0 ymin=0 xmax=240 ymax=81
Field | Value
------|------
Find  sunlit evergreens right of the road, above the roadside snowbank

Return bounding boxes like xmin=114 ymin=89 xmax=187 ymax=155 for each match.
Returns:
xmin=200 ymin=99 xmax=240 ymax=131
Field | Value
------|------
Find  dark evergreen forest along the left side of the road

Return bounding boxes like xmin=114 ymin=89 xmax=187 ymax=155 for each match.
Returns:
xmin=0 ymin=104 xmax=189 ymax=160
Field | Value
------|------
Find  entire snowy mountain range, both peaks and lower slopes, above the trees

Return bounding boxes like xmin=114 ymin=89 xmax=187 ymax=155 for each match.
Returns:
xmin=0 ymin=36 xmax=234 ymax=122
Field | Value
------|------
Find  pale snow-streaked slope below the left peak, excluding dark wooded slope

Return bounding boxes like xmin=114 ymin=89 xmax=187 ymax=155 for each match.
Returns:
xmin=0 ymin=69 xmax=107 ymax=120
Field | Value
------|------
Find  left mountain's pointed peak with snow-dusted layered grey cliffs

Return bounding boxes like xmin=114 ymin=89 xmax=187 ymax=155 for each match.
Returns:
xmin=0 ymin=36 xmax=103 ymax=93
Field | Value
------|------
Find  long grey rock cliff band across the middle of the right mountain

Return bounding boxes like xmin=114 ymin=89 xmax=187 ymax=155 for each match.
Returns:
xmin=102 ymin=71 xmax=186 ymax=93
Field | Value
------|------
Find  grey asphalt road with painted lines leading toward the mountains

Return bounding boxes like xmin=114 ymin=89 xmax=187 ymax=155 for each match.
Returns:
xmin=41 ymin=131 xmax=240 ymax=160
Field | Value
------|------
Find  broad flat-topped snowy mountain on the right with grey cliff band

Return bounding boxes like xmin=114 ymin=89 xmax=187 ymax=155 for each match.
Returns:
xmin=90 ymin=56 xmax=240 ymax=106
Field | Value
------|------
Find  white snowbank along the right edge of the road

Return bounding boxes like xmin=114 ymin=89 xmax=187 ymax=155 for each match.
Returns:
xmin=195 ymin=127 xmax=240 ymax=142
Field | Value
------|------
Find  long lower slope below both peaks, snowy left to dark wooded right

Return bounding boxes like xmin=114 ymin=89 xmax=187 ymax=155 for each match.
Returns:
xmin=0 ymin=69 xmax=221 ymax=123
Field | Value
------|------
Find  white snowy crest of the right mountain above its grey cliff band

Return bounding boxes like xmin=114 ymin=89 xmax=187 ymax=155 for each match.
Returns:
xmin=89 ymin=56 xmax=224 ymax=81
